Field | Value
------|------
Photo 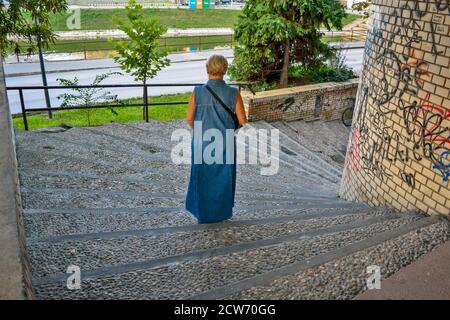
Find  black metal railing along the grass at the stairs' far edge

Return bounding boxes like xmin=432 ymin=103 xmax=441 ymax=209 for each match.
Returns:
xmin=6 ymin=82 xmax=246 ymax=131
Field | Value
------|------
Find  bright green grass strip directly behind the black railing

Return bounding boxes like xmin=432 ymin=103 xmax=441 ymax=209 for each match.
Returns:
xmin=13 ymin=92 xmax=191 ymax=130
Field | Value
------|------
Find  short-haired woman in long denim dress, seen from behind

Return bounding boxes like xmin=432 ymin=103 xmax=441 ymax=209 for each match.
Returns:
xmin=186 ymin=55 xmax=247 ymax=223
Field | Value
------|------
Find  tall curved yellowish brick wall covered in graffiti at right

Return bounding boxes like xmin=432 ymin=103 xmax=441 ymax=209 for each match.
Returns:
xmin=340 ymin=0 xmax=450 ymax=215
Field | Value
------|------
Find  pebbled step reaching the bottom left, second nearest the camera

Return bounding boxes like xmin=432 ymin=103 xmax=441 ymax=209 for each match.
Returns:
xmin=30 ymin=215 xmax=440 ymax=299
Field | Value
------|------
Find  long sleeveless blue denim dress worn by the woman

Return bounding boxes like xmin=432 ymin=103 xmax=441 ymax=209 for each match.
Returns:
xmin=186 ymin=79 xmax=238 ymax=223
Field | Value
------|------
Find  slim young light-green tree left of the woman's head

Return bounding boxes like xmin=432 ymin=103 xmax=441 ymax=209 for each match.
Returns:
xmin=110 ymin=0 xmax=170 ymax=119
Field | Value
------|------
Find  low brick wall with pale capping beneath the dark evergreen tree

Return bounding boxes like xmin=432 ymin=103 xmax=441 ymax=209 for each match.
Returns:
xmin=243 ymin=79 xmax=358 ymax=122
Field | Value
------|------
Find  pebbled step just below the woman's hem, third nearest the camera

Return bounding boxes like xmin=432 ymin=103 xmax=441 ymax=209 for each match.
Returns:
xmin=27 ymin=212 xmax=397 ymax=277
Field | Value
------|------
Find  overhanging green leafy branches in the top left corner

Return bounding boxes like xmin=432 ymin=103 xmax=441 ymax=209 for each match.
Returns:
xmin=0 ymin=0 xmax=67 ymax=56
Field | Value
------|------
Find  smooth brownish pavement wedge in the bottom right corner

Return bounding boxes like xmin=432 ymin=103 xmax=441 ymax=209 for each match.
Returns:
xmin=356 ymin=241 xmax=450 ymax=300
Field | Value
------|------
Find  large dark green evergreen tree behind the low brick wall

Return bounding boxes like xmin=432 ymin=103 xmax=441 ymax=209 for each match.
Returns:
xmin=230 ymin=0 xmax=345 ymax=87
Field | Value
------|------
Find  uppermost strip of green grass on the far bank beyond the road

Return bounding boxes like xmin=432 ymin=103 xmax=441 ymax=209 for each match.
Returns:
xmin=51 ymin=8 xmax=240 ymax=31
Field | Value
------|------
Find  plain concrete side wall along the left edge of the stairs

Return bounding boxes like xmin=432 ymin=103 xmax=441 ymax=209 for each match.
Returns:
xmin=0 ymin=59 xmax=33 ymax=299
